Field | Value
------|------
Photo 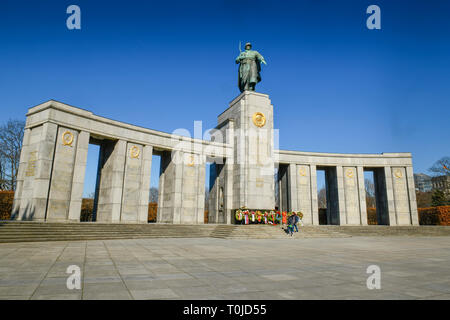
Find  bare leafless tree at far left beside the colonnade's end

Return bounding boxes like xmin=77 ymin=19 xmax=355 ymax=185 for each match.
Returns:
xmin=0 ymin=119 xmax=25 ymax=190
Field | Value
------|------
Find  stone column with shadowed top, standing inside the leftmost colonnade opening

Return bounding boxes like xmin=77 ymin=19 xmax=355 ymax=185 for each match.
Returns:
xmin=97 ymin=140 xmax=127 ymax=223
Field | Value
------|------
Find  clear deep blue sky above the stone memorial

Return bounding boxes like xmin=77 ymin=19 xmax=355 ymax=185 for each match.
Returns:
xmin=0 ymin=0 xmax=450 ymax=195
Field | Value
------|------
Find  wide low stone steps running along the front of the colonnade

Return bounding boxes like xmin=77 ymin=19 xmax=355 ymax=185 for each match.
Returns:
xmin=0 ymin=221 xmax=450 ymax=243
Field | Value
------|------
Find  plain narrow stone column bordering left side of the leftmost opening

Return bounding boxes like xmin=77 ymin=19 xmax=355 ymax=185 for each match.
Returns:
xmin=68 ymin=131 xmax=90 ymax=222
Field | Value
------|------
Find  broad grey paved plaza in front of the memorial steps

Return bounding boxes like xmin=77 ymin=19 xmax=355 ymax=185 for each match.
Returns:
xmin=0 ymin=237 xmax=450 ymax=299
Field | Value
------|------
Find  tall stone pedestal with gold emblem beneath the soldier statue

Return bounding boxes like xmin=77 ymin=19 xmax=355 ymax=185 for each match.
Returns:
xmin=218 ymin=91 xmax=275 ymax=218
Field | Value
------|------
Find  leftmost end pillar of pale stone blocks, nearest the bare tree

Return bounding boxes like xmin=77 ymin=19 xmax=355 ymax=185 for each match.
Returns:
xmin=17 ymin=122 xmax=58 ymax=221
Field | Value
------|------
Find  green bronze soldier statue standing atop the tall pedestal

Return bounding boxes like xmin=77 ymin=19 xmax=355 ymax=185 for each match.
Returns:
xmin=236 ymin=42 xmax=267 ymax=92
